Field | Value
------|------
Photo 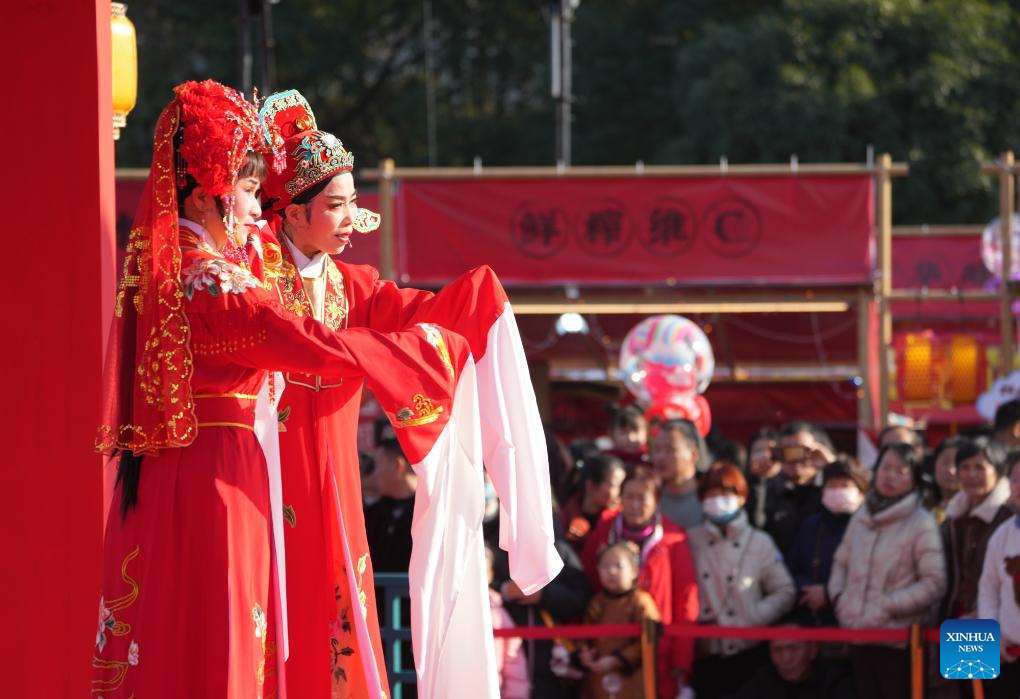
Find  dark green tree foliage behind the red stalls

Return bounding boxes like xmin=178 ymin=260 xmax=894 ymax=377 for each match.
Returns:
xmin=117 ymin=0 xmax=1020 ymax=222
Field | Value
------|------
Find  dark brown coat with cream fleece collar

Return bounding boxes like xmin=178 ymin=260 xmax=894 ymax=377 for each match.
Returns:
xmin=936 ymin=478 xmax=1013 ymax=626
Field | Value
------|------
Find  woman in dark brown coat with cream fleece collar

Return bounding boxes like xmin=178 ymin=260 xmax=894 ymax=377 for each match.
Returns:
xmin=938 ymin=437 xmax=1014 ymax=621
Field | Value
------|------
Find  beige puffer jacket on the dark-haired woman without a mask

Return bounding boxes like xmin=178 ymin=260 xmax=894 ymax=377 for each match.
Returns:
xmin=828 ymin=493 xmax=946 ymax=629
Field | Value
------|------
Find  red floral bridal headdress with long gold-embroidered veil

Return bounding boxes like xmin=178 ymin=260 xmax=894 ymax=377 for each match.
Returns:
xmin=96 ymin=81 xmax=263 ymax=454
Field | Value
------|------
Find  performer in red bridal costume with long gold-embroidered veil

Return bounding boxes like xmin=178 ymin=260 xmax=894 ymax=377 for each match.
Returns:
xmin=92 ymin=81 xmax=467 ymax=699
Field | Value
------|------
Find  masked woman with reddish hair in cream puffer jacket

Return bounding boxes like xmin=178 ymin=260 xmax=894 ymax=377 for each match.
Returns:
xmin=689 ymin=462 xmax=795 ymax=699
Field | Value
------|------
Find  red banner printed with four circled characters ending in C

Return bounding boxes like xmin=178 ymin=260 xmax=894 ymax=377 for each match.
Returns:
xmin=396 ymin=176 xmax=873 ymax=286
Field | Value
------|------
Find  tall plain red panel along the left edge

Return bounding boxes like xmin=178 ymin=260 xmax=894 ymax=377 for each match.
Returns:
xmin=0 ymin=0 xmax=113 ymax=697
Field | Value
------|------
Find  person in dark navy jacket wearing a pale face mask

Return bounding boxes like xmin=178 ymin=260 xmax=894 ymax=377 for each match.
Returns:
xmin=786 ymin=456 xmax=870 ymax=627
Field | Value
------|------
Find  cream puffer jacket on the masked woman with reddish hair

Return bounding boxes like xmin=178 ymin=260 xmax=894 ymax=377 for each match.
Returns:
xmin=687 ymin=511 xmax=795 ymax=655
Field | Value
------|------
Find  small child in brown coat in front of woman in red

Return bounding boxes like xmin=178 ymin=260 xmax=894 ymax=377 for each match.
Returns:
xmin=580 ymin=541 xmax=659 ymax=699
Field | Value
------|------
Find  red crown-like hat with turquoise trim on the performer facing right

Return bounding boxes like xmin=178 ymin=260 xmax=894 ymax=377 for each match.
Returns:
xmin=259 ymin=90 xmax=381 ymax=233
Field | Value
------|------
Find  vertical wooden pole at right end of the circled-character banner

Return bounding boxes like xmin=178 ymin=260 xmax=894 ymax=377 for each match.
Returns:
xmin=875 ymin=153 xmax=893 ymax=429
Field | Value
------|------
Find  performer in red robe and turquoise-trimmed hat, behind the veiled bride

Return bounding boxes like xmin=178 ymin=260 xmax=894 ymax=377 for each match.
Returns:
xmin=252 ymin=90 xmax=561 ymax=699
